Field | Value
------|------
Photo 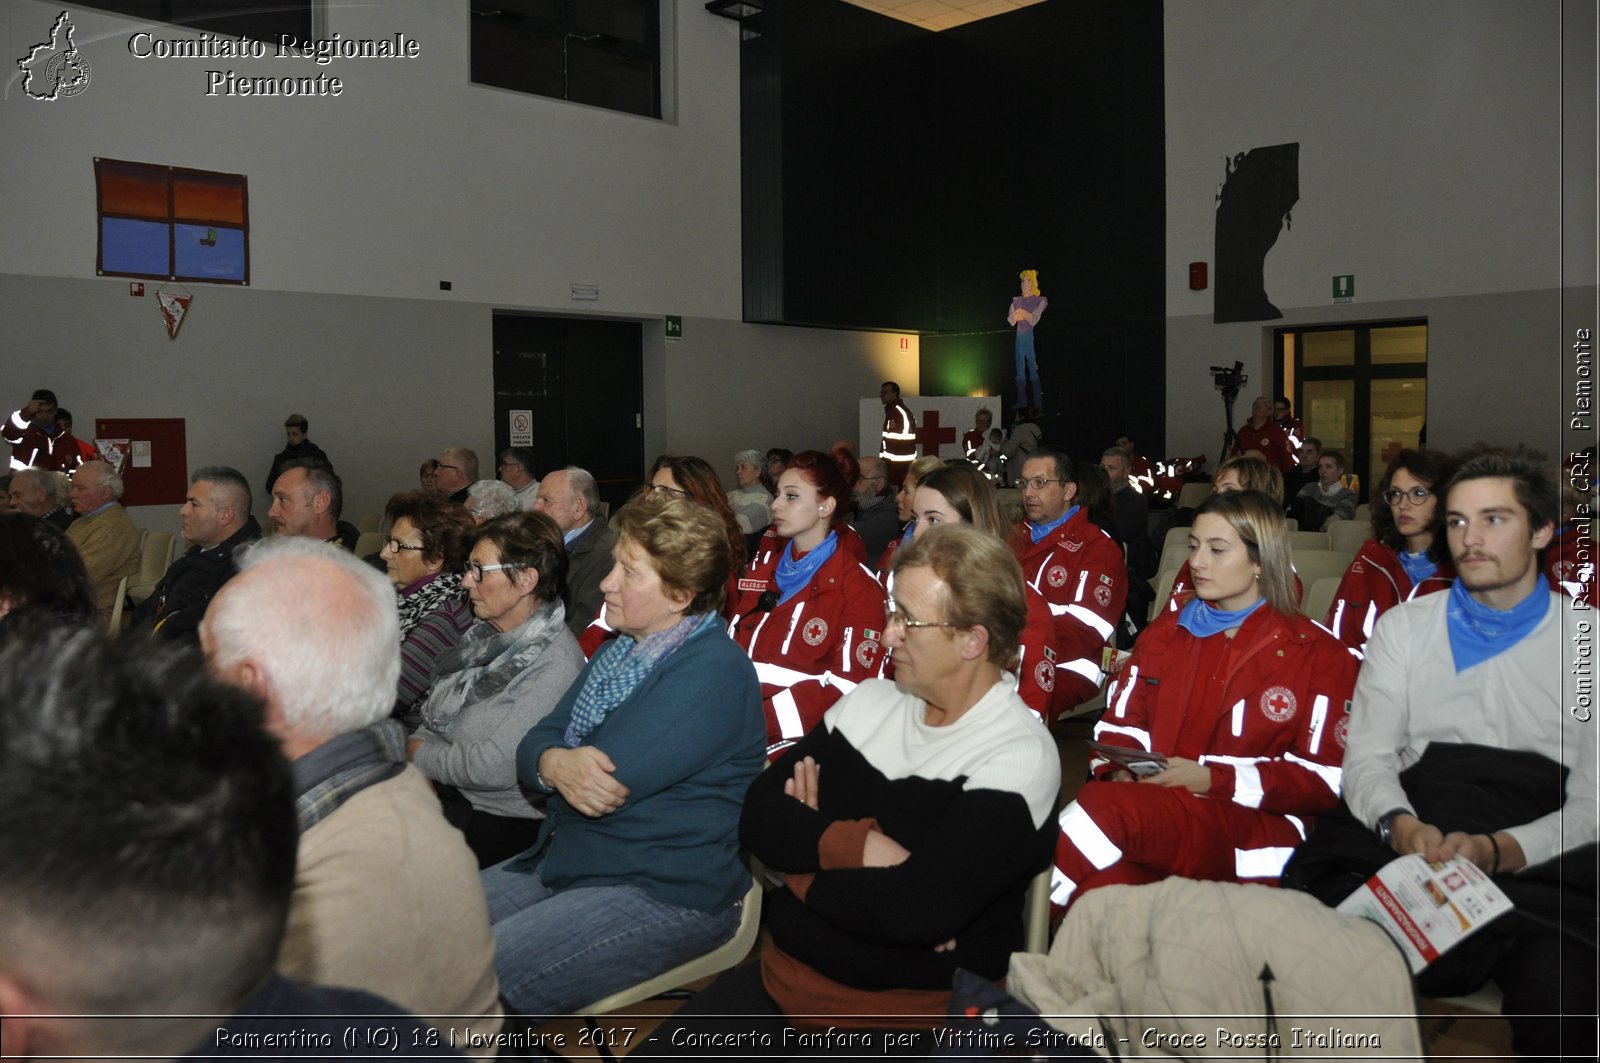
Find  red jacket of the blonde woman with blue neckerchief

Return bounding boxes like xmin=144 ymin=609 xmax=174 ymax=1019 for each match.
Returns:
xmin=1090 ymin=607 xmax=1358 ymax=816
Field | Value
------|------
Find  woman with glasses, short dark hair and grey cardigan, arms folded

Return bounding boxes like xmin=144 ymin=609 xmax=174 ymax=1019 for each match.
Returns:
xmin=408 ymin=512 xmax=584 ymax=868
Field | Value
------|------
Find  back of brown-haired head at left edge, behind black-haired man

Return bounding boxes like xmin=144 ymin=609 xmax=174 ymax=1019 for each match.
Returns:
xmin=0 ymin=512 xmax=99 ymax=644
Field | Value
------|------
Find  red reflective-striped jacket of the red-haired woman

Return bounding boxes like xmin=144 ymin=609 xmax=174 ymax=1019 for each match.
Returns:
xmin=728 ymin=530 xmax=883 ymax=757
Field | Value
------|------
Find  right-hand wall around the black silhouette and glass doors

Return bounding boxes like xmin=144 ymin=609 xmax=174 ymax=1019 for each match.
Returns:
xmin=1165 ymin=0 xmax=1595 ymax=459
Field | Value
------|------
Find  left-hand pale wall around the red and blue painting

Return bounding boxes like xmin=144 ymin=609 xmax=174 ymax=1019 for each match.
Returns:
xmin=0 ymin=0 xmax=917 ymax=525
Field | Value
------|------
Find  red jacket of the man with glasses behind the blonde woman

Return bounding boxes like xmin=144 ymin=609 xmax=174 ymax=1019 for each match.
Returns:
xmin=1011 ymin=509 xmax=1128 ymax=719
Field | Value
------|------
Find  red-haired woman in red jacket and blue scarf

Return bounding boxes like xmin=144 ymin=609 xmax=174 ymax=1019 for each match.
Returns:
xmin=728 ymin=450 xmax=883 ymax=757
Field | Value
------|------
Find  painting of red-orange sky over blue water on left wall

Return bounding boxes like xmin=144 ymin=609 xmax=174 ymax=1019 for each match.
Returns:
xmin=94 ymin=158 xmax=250 ymax=285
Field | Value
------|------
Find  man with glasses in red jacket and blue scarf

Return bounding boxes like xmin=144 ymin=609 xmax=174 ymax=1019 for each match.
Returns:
xmin=1011 ymin=447 xmax=1128 ymax=719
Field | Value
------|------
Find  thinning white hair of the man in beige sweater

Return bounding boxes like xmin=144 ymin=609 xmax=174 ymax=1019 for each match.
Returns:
xmin=203 ymin=535 xmax=400 ymax=738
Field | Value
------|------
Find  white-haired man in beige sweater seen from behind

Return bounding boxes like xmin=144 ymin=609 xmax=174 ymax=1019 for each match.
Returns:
xmin=200 ymin=536 xmax=502 ymax=1034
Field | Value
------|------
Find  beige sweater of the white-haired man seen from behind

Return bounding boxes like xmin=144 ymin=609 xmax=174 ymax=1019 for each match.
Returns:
xmin=278 ymin=765 xmax=502 ymax=1047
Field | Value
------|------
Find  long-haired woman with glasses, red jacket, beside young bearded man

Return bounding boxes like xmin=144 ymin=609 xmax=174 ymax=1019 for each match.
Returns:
xmin=1328 ymin=450 xmax=1456 ymax=650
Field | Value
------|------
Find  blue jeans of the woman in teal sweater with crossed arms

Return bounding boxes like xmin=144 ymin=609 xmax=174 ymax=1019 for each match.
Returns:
xmin=482 ymin=863 xmax=744 ymax=1015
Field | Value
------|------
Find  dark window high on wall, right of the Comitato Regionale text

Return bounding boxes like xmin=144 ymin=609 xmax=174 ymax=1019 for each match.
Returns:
xmin=472 ymin=0 xmax=661 ymax=118
